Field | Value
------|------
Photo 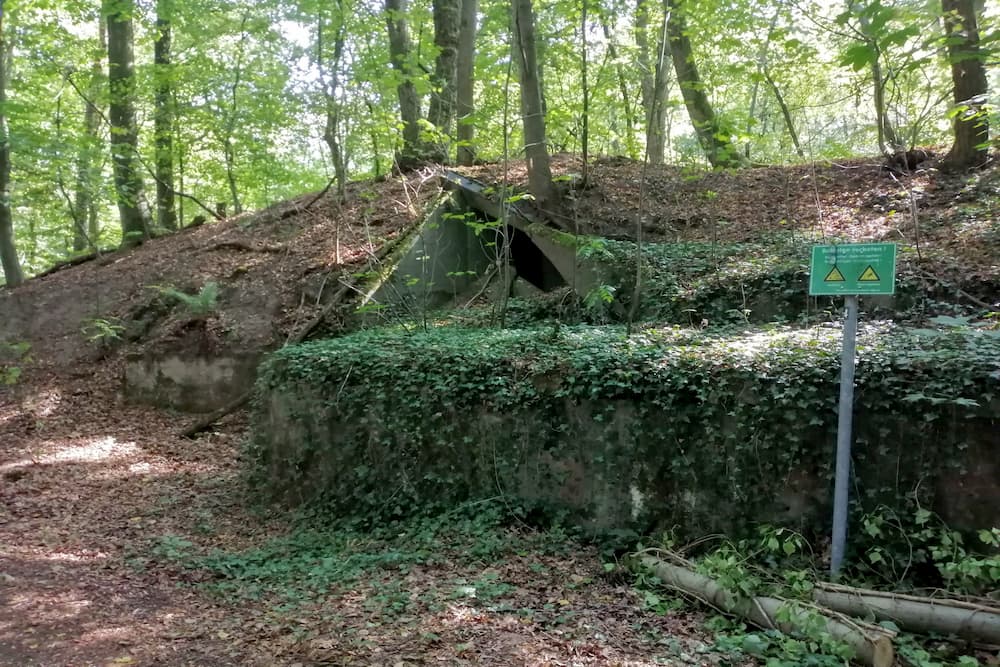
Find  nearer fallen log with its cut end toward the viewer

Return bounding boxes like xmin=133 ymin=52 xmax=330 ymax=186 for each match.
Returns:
xmin=640 ymin=555 xmax=895 ymax=667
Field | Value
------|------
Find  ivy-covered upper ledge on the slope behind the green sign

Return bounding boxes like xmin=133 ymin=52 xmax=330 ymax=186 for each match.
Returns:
xmin=580 ymin=235 xmax=988 ymax=326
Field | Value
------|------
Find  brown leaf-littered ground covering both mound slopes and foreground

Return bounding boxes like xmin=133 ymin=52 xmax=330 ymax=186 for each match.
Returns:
xmin=0 ymin=156 xmax=1000 ymax=667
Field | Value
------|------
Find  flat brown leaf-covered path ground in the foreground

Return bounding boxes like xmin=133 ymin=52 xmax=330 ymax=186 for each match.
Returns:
xmin=0 ymin=364 xmax=744 ymax=667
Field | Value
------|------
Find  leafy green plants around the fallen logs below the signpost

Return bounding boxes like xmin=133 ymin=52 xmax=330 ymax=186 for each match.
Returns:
xmin=634 ymin=508 xmax=1000 ymax=667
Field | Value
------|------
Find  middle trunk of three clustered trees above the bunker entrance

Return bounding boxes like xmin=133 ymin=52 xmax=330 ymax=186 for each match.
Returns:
xmin=427 ymin=0 xmax=462 ymax=162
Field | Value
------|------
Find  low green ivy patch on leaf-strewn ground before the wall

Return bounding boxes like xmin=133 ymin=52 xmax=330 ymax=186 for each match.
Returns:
xmin=142 ymin=499 xmax=574 ymax=614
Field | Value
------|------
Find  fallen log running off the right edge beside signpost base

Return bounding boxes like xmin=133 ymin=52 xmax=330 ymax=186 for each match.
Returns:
xmin=813 ymin=583 xmax=1000 ymax=644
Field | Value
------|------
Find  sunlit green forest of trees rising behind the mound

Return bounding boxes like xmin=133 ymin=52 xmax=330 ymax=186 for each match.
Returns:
xmin=0 ymin=0 xmax=997 ymax=285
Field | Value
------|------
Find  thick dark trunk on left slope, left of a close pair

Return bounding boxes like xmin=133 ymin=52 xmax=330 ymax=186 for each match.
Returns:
xmin=103 ymin=0 xmax=149 ymax=247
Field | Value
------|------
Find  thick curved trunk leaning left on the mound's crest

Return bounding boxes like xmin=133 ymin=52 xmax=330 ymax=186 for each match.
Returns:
xmin=666 ymin=0 xmax=747 ymax=168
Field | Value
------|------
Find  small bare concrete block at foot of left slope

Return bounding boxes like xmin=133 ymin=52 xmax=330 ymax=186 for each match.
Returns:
xmin=124 ymin=351 xmax=261 ymax=413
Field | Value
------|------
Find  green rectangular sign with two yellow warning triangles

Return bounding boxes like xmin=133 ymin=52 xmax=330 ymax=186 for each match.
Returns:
xmin=809 ymin=243 xmax=896 ymax=296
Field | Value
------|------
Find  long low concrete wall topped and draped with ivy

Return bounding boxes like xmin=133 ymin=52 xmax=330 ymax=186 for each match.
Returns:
xmin=248 ymin=325 xmax=1000 ymax=534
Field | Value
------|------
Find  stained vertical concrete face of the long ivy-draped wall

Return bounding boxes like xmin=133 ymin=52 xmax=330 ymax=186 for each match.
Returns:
xmin=257 ymin=385 xmax=1000 ymax=535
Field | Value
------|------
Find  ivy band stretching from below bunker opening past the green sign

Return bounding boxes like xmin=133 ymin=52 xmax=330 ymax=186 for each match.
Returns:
xmin=426 ymin=236 xmax=978 ymax=328
